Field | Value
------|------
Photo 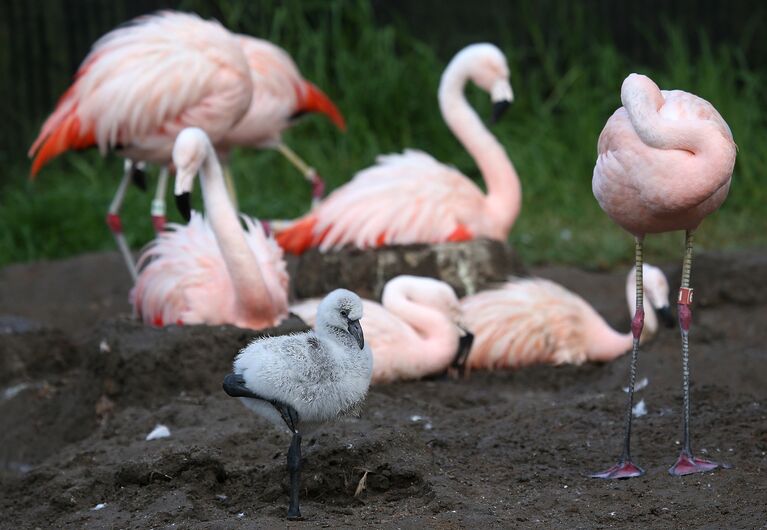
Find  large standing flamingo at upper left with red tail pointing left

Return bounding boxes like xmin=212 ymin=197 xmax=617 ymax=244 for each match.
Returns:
xmin=29 ymin=11 xmax=253 ymax=279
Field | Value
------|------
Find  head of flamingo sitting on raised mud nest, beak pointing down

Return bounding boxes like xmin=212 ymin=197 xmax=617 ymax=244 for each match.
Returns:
xmin=466 ymin=43 xmax=514 ymax=123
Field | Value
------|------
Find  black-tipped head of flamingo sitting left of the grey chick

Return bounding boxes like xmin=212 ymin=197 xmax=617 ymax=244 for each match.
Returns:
xmin=173 ymin=127 xmax=213 ymax=221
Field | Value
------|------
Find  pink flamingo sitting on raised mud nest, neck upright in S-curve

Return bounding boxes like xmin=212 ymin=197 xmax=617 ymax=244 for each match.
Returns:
xmin=277 ymin=44 xmax=521 ymax=254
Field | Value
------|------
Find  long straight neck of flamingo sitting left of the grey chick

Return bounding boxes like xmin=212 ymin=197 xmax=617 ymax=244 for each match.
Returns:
xmin=200 ymin=146 xmax=272 ymax=317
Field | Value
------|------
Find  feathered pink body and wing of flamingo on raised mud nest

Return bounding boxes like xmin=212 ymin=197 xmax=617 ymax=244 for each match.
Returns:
xmin=277 ymin=150 xmax=484 ymax=253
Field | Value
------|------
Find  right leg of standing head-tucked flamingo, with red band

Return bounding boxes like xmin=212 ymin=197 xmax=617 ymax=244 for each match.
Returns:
xmin=668 ymin=230 xmax=730 ymax=476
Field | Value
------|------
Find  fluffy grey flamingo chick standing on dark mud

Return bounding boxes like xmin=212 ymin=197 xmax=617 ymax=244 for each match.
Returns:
xmin=224 ymin=289 xmax=373 ymax=519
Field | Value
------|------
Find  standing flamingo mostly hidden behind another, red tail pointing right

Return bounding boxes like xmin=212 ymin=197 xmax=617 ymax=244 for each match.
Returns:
xmin=216 ymin=35 xmax=346 ymax=206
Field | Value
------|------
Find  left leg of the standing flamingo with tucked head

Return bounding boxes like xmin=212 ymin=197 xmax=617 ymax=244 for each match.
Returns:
xmin=591 ymin=237 xmax=644 ymax=479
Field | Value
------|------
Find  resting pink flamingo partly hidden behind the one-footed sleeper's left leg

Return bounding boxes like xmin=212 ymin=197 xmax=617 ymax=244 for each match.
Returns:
xmin=461 ymin=264 xmax=673 ymax=369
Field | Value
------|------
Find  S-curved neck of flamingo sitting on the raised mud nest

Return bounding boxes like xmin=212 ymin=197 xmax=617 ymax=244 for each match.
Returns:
xmin=439 ymin=55 xmax=522 ymax=233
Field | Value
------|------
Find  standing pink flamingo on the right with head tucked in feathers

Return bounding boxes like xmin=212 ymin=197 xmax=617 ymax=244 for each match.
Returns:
xmin=592 ymin=74 xmax=737 ymax=478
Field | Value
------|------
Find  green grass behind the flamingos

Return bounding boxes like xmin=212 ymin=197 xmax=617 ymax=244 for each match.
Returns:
xmin=0 ymin=0 xmax=767 ymax=268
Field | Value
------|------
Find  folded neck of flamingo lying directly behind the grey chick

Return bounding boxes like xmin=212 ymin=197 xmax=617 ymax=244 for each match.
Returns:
xmin=381 ymin=285 xmax=458 ymax=369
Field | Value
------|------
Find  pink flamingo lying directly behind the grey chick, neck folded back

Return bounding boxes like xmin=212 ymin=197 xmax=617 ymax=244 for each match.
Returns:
xmin=290 ymin=275 xmax=471 ymax=383
